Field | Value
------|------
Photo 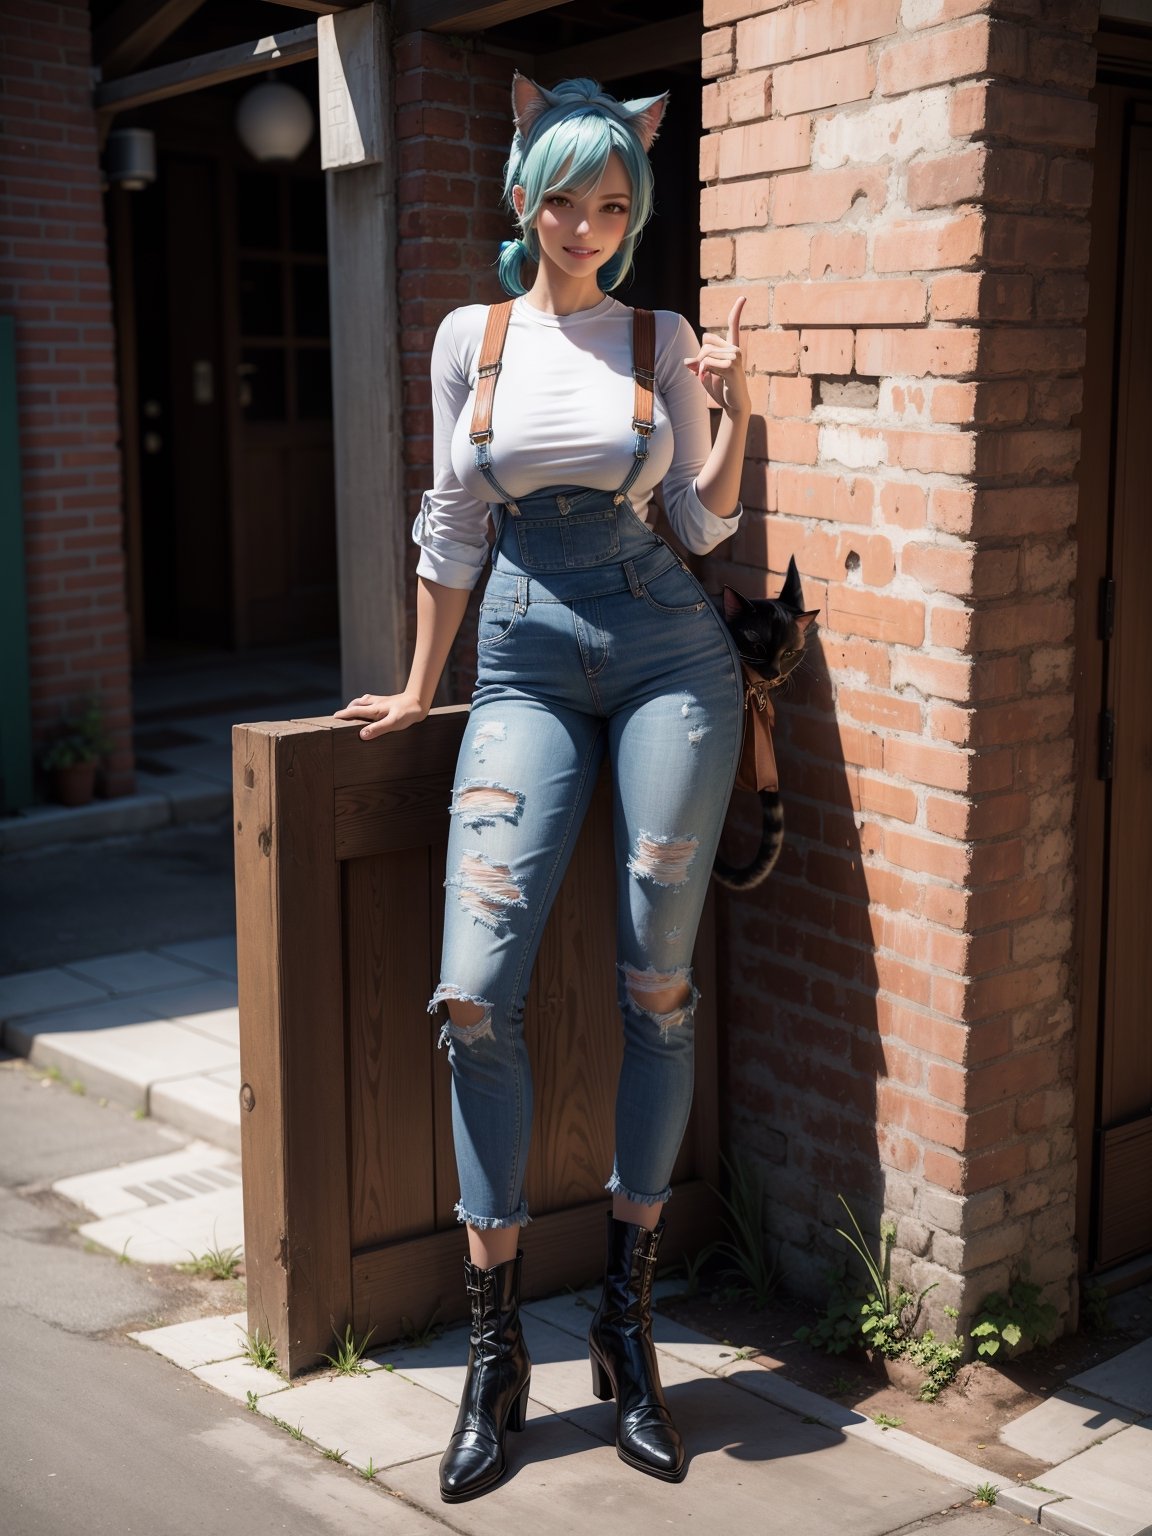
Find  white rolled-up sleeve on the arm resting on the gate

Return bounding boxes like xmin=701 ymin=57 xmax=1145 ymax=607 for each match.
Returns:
xmin=412 ymin=315 xmax=488 ymax=590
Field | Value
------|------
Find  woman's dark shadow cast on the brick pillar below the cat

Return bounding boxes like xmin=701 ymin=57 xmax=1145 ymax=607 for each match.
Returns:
xmin=717 ymin=629 xmax=890 ymax=1295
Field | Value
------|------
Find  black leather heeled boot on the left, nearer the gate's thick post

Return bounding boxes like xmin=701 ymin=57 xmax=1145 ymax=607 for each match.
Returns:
xmin=439 ymin=1249 xmax=531 ymax=1504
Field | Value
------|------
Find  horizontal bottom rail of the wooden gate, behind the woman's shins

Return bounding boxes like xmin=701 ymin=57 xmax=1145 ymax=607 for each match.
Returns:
xmin=350 ymin=1180 xmax=722 ymax=1357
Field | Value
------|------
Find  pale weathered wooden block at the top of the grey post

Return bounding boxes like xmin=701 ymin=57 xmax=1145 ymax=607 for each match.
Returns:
xmin=316 ymin=5 xmax=389 ymax=170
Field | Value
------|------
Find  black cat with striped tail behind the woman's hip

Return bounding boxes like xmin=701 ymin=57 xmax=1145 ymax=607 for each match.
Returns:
xmin=713 ymin=559 xmax=820 ymax=891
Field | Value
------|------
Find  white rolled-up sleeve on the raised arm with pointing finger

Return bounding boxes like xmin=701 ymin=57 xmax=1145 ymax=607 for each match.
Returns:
xmin=656 ymin=315 xmax=743 ymax=554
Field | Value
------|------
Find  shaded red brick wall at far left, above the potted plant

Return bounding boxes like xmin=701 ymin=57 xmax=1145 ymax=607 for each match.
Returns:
xmin=0 ymin=0 xmax=134 ymax=794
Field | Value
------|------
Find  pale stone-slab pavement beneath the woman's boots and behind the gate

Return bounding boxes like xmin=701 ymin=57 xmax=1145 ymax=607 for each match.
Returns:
xmin=0 ymin=935 xmax=1152 ymax=1536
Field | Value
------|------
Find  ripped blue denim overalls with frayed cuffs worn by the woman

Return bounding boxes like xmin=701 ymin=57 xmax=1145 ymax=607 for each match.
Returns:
xmin=429 ymin=487 xmax=743 ymax=1229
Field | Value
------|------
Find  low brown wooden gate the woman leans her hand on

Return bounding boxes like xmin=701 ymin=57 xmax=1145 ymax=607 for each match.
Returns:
xmin=232 ymin=707 xmax=719 ymax=1376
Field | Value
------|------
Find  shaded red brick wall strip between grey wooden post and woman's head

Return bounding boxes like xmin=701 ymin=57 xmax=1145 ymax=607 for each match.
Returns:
xmin=395 ymin=32 xmax=511 ymax=703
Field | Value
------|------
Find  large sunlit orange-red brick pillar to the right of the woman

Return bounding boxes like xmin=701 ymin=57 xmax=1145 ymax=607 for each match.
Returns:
xmin=700 ymin=0 xmax=1097 ymax=1345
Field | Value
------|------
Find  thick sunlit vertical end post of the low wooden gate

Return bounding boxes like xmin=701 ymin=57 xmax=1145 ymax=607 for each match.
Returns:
xmin=233 ymin=725 xmax=352 ymax=1375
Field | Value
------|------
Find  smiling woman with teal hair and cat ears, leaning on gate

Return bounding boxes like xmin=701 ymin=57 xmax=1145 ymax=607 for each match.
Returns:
xmin=338 ymin=75 xmax=750 ymax=1501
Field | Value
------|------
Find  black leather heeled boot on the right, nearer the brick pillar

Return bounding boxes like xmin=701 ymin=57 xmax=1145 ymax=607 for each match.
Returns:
xmin=588 ymin=1212 xmax=685 ymax=1482
